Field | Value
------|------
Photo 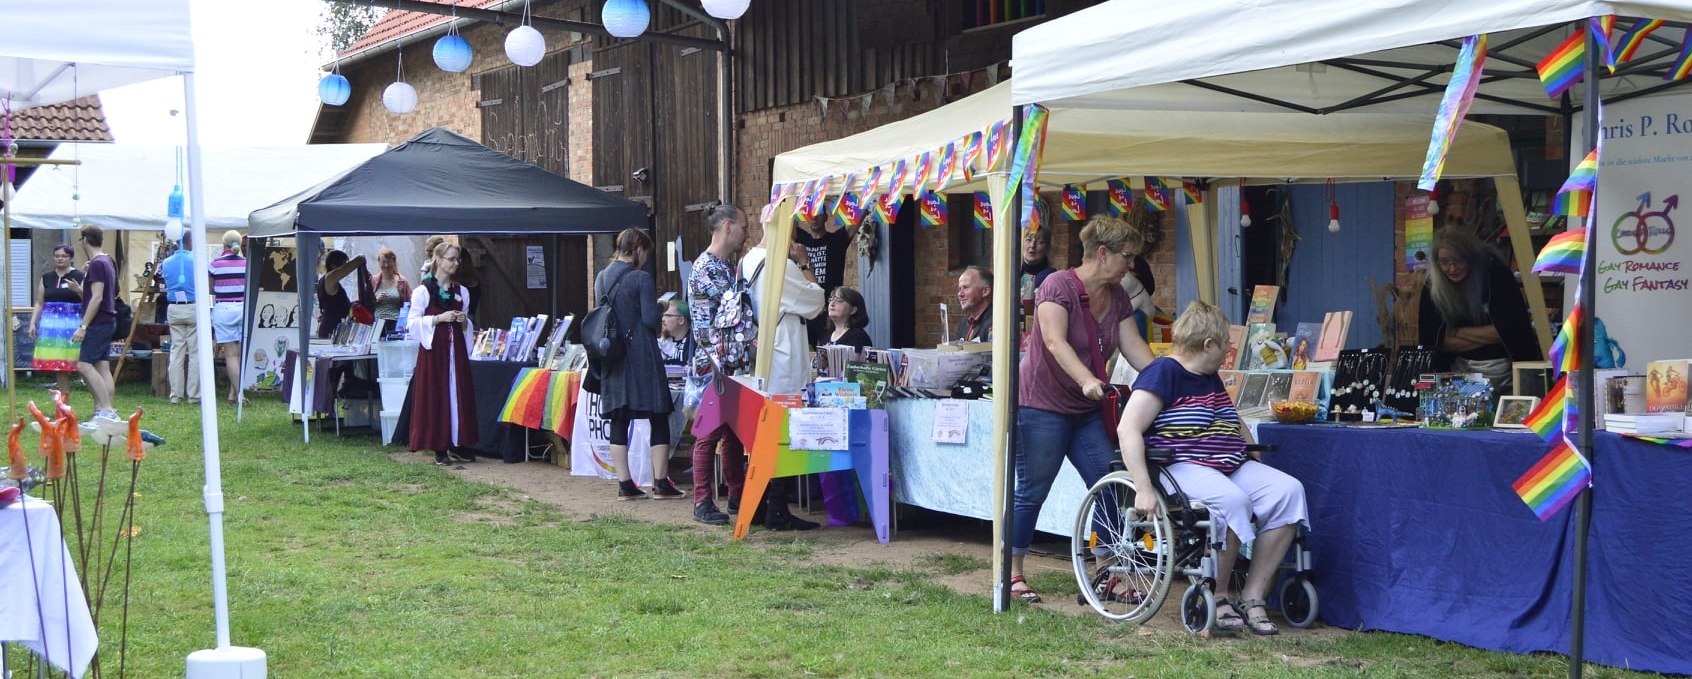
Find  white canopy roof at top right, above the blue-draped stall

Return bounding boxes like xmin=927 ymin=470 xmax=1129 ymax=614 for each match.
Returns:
xmin=1012 ymin=0 xmax=1692 ymax=113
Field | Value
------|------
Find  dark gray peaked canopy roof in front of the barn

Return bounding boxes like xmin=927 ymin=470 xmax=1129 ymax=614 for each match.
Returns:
xmin=249 ymin=127 xmax=646 ymax=237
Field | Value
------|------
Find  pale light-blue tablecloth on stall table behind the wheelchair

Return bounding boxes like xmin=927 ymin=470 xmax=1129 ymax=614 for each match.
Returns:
xmin=887 ymin=398 xmax=1086 ymax=537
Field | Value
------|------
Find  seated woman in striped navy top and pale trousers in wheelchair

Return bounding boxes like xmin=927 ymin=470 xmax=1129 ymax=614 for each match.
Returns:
xmin=1117 ymin=301 xmax=1310 ymax=635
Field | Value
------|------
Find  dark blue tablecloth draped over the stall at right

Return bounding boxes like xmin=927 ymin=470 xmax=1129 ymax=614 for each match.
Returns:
xmin=1259 ymin=425 xmax=1692 ymax=674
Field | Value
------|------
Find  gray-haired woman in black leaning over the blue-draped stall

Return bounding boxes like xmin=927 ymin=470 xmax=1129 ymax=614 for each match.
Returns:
xmin=1420 ymin=229 xmax=1543 ymax=393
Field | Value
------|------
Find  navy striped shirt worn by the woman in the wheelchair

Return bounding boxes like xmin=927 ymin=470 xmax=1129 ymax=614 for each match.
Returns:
xmin=1134 ymin=356 xmax=1245 ymax=474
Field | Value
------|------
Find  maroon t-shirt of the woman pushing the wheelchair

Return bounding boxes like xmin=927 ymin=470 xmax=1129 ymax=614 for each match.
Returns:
xmin=1017 ymin=269 xmax=1134 ymax=415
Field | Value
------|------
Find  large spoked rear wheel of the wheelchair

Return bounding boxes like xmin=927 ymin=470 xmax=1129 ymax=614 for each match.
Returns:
xmin=1069 ymin=472 xmax=1174 ymax=623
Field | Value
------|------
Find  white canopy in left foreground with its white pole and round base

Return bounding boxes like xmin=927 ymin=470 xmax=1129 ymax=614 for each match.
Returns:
xmin=0 ymin=0 xmax=266 ymax=677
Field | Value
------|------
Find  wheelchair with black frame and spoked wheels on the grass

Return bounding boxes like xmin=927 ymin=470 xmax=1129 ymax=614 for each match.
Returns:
xmin=1069 ymin=445 xmax=1318 ymax=635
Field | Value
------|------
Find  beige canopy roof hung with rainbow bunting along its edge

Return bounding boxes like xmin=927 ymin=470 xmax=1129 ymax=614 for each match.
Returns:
xmin=773 ymin=76 xmax=1516 ymax=190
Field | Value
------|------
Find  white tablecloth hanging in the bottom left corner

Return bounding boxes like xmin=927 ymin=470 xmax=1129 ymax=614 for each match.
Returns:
xmin=0 ymin=498 xmax=100 ymax=677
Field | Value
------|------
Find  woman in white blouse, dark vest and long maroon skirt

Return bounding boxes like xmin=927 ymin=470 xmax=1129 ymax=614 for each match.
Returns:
xmin=406 ymin=244 xmax=477 ymax=466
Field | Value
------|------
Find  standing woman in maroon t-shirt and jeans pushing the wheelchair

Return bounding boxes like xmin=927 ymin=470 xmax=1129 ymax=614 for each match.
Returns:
xmin=1008 ymin=217 xmax=1152 ymax=603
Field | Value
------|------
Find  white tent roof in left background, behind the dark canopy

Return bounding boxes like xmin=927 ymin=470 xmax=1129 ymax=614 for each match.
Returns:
xmin=12 ymin=144 xmax=387 ymax=230
